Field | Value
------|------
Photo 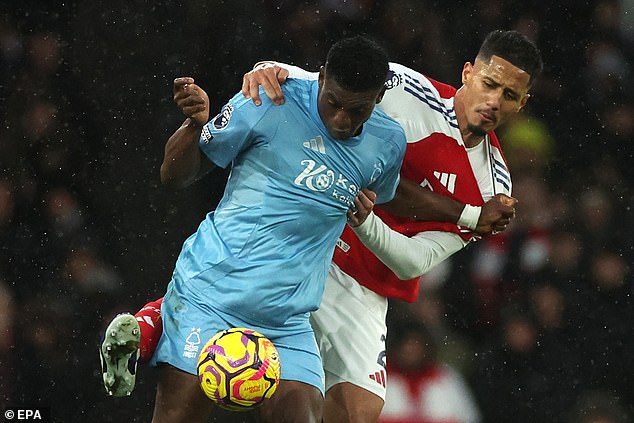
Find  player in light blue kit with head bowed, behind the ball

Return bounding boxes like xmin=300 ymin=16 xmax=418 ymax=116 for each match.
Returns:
xmin=147 ymin=36 xmax=406 ymax=423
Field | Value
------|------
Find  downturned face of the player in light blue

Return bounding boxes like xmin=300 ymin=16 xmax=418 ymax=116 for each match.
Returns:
xmin=317 ymin=69 xmax=385 ymax=140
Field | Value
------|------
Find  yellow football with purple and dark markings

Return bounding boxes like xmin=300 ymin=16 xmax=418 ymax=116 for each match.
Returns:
xmin=198 ymin=328 xmax=281 ymax=411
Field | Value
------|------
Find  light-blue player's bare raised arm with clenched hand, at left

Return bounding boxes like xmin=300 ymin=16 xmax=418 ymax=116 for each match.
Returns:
xmin=161 ymin=77 xmax=209 ymax=187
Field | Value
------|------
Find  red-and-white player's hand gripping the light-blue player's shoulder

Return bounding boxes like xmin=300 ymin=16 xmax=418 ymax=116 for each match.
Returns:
xmin=242 ymin=62 xmax=288 ymax=106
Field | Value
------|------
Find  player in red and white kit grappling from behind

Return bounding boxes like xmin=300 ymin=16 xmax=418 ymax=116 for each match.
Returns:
xmin=99 ymin=31 xmax=542 ymax=422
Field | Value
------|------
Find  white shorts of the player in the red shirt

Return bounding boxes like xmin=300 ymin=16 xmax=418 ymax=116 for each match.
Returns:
xmin=311 ymin=263 xmax=388 ymax=399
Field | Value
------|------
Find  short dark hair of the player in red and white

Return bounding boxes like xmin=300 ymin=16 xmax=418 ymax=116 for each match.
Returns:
xmin=477 ymin=29 xmax=544 ymax=86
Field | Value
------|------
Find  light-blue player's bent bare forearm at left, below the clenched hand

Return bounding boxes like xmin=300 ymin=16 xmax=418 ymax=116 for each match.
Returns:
xmin=161 ymin=118 xmax=202 ymax=188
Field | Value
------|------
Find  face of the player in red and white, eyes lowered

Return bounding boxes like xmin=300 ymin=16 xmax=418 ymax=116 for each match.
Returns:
xmin=456 ymin=56 xmax=530 ymax=136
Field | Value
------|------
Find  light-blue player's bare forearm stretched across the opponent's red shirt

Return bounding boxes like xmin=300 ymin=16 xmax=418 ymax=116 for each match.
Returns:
xmin=377 ymin=179 xmax=464 ymax=223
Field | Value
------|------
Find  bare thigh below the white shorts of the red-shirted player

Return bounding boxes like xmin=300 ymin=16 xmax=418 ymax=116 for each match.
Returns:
xmin=324 ymin=382 xmax=384 ymax=423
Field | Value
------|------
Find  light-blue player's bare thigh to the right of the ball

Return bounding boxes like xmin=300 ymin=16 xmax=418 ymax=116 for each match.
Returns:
xmin=258 ymin=380 xmax=324 ymax=423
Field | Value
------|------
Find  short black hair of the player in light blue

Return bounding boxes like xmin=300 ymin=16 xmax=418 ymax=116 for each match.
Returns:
xmin=326 ymin=35 xmax=389 ymax=92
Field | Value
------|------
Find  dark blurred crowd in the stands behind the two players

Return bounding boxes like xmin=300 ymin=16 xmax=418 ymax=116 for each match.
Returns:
xmin=0 ymin=0 xmax=634 ymax=423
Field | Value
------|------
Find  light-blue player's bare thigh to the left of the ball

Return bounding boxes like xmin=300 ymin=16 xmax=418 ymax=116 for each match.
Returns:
xmin=152 ymin=365 xmax=213 ymax=423
